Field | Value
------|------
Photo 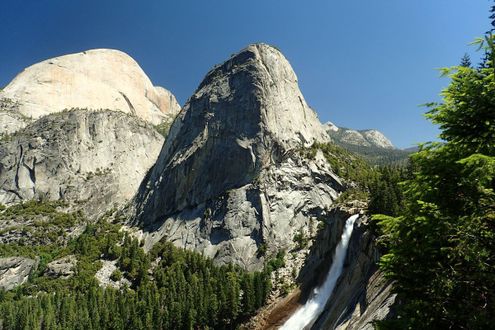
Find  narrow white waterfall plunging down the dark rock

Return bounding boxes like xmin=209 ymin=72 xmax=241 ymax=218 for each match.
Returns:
xmin=280 ymin=214 xmax=359 ymax=330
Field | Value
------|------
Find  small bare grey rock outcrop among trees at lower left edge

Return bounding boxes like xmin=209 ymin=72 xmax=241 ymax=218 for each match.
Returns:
xmin=0 ymin=257 xmax=37 ymax=291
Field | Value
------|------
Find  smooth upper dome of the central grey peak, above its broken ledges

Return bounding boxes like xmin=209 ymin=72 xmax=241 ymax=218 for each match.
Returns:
xmin=134 ymin=44 xmax=328 ymax=226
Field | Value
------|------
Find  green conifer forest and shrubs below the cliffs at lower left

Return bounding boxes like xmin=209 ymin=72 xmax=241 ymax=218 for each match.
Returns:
xmin=0 ymin=221 xmax=272 ymax=329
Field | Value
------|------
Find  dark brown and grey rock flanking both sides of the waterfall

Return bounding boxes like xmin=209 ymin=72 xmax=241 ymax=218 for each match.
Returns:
xmin=243 ymin=203 xmax=395 ymax=330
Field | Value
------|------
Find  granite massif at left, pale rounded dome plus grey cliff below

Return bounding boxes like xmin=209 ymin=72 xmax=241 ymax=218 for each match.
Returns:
xmin=0 ymin=49 xmax=180 ymax=218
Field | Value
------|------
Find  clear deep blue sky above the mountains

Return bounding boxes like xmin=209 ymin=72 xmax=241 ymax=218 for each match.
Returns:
xmin=0 ymin=0 xmax=491 ymax=147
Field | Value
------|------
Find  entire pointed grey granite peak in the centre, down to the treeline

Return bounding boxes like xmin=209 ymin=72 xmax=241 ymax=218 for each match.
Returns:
xmin=135 ymin=44 xmax=342 ymax=269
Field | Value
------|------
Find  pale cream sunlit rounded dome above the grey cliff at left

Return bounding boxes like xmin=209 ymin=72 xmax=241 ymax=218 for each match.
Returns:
xmin=0 ymin=49 xmax=180 ymax=124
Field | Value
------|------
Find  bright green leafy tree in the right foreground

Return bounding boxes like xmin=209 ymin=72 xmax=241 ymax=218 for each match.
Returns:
xmin=374 ymin=32 xmax=495 ymax=329
